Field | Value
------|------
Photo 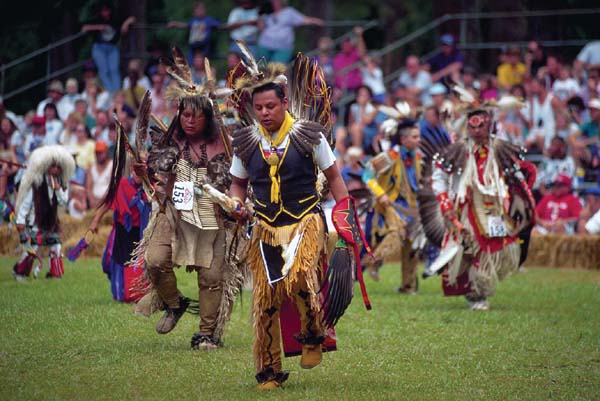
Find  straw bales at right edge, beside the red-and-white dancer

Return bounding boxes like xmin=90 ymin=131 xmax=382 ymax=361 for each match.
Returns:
xmin=525 ymin=234 xmax=600 ymax=270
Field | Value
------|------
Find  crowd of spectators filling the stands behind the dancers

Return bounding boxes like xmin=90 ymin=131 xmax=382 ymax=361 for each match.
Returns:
xmin=0 ymin=0 xmax=600 ymax=233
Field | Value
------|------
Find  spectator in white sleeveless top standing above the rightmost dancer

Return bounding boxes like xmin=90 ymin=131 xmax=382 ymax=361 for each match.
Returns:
xmin=521 ymin=77 xmax=560 ymax=153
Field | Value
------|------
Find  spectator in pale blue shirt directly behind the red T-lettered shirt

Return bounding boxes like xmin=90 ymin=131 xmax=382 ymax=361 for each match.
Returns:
xmin=536 ymin=136 xmax=577 ymax=194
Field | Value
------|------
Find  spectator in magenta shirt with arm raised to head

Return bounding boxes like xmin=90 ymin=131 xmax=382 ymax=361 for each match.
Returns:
xmin=333 ymin=26 xmax=367 ymax=91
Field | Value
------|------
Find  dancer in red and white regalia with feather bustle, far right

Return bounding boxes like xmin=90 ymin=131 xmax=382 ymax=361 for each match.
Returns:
xmin=419 ymin=85 xmax=535 ymax=310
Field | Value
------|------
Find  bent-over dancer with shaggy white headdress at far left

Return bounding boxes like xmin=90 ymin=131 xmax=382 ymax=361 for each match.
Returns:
xmin=13 ymin=145 xmax=75 ymax=281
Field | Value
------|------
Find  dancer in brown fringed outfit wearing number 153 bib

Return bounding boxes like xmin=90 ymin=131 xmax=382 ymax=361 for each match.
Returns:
xmin=107 ymin=48 xmax=243 ymax=350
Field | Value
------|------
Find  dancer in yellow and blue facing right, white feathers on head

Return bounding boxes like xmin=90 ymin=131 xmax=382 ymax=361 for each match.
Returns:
xmin=362 ymin=103 xmax=421 ymax=294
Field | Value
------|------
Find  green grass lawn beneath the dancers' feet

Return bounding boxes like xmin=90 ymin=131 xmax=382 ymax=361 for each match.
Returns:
xmin=0 ymin=258 xmax=600 ymax=401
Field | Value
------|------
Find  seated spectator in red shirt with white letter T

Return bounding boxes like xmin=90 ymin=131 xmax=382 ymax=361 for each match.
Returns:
xmin=535 ymin=174 xmax=582 ymax=234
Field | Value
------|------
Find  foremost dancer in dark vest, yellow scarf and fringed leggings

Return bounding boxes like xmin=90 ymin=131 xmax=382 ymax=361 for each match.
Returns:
xmin=230 ymin=42 xmax=370 ymax=390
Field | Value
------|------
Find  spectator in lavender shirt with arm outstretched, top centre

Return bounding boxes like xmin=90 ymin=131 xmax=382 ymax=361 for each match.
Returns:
xmin=257 ymin=0 xmax=325 ymax=63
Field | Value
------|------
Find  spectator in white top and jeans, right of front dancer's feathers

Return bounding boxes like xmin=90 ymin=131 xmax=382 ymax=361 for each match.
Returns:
xmin=348 ymin=86 xmax=378 ymax=155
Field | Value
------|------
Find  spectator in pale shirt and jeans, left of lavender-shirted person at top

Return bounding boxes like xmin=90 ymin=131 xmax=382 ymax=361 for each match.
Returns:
xmin=227 ymin=0 xmax=258 ymax=55
